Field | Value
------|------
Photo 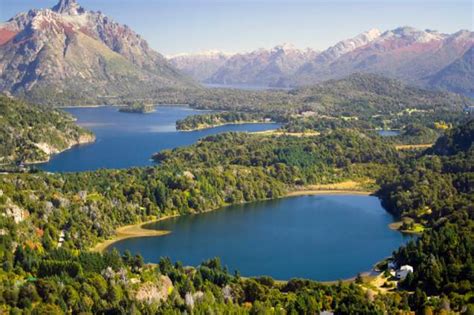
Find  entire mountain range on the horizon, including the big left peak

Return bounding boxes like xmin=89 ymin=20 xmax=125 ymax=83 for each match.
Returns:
xmin=0 ymin=0 xmax=474 ymax=105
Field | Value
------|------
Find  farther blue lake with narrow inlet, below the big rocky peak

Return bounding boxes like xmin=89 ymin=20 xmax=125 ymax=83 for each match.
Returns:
xmin=38 ymin=106 xmax=280 ymax=172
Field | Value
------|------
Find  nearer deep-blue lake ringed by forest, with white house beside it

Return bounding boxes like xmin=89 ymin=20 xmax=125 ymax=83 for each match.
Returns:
xmin=109 ymin=195 xmax=408 ymax=281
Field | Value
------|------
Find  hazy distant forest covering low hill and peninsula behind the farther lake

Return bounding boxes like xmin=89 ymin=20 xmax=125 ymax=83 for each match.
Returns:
xmin=177 ymin=74 xmax=474 ymax=143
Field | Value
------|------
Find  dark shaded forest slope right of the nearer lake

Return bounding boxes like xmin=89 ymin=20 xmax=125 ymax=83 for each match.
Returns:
xmin=380 ymin=120 xmax=474 ymax=310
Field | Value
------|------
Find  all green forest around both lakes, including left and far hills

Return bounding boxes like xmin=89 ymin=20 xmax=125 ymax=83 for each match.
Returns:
xmin=0 ymin=75 xmax=474 ymax=314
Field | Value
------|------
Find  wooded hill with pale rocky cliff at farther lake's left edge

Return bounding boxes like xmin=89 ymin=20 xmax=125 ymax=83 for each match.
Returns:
xmin=0 ymin=94 xmax=94 ymax=165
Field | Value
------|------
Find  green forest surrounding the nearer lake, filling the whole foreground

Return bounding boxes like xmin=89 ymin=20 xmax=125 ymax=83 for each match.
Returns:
xmin=0 ymin=120 xmax=474 ymax=314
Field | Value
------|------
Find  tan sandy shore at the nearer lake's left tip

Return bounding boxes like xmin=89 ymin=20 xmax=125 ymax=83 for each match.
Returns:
xmin=91 ymin=215 xmax=178 ymax=252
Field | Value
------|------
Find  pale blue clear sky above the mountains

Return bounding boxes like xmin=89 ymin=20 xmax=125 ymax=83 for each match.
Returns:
xmin=0 ymin=0 xmax=474 ymax=55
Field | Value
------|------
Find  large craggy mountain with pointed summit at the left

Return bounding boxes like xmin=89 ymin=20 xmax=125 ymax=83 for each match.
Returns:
xmin=0 ymin=0 xmax=195 ymax=104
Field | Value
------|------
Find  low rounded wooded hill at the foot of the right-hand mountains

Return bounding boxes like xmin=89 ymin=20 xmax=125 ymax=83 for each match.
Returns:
xmin=185 ymin=73 xmax=473 ymax=117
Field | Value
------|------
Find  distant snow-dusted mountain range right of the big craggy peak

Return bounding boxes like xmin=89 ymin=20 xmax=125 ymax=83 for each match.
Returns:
xmin=170 ymin=27 xmax=474 ymax=93
